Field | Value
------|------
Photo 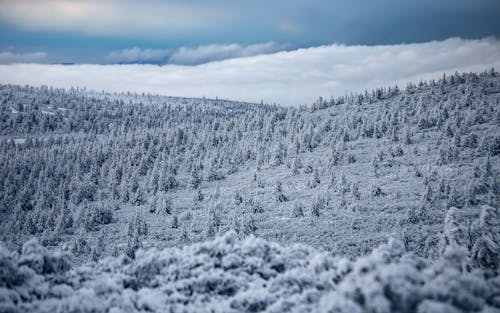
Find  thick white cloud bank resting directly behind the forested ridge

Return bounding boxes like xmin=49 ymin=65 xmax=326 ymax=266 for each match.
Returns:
xmin=0 ymin=38 xmax=500 ymax=105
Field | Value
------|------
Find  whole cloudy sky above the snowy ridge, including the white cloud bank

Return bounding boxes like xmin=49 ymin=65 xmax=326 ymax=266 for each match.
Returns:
xmin=0 ymin=0 xmax=500 ymax=105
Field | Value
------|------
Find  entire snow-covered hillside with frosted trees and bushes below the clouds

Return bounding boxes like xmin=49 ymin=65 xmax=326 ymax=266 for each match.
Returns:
xmin=0 ymin=69 xmax=500 ymax=313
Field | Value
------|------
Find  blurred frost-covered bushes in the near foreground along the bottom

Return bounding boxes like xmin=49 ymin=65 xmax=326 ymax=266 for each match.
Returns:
xmin=0 ymin=232 xmax=500 ymax=313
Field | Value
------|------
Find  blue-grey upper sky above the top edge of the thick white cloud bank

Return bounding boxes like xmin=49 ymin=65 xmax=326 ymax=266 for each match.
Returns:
xmin=0 ymin=0 xmax=500 ymax=65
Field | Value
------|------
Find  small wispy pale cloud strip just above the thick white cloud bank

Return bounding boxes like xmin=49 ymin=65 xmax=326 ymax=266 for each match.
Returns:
xmin=108 ymin=42 xmax=287 ymax=65
